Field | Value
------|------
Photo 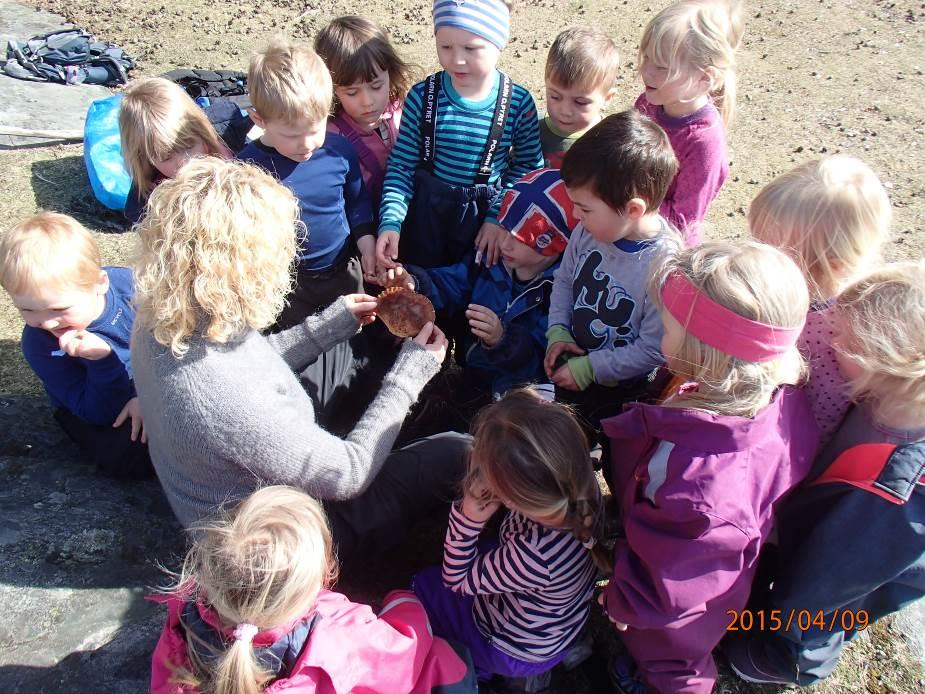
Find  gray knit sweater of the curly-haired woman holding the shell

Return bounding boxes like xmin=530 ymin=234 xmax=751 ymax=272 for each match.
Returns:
xmin=132 ymin=299 xmax=440 ymax=527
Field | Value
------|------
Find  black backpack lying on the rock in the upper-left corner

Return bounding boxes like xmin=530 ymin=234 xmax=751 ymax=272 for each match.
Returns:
xmin=3 ymin=28 xmax=135 ymax=87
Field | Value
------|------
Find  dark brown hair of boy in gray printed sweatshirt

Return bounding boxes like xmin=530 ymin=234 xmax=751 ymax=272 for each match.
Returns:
xmin=562 ymin=110 xmax=678 ymax=212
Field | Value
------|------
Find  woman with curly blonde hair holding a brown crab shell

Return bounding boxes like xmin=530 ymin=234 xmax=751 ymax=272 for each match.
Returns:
xmin=132 ymin=158 xmax=468 ymax=561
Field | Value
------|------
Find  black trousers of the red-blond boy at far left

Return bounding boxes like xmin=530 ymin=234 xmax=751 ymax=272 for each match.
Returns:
xmin=55 ymin=407 xmax=154 ymax=480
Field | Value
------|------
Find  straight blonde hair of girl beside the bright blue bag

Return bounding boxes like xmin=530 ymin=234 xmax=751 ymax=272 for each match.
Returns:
xmin=119 ymin=77 xmax=231 ymax=195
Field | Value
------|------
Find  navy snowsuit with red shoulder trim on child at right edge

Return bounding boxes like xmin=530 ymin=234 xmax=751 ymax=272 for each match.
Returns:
xmin=772 ymin=441 xmax=925 ymax=646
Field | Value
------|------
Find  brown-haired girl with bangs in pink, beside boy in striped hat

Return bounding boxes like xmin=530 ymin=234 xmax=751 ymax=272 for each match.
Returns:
xmin=315 ymin=17 xmax=414 ymax=213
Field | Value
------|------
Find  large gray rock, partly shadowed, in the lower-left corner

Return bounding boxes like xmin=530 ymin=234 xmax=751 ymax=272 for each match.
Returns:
xmin=0 ymin=397 xmax=184 ymax=694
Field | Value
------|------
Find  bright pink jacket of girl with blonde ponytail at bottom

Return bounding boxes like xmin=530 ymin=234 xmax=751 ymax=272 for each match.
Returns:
xmin=151 ymin=590 xmax=476 ymax=694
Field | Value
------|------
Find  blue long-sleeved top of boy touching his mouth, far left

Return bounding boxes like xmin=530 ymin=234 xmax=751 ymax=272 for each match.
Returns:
xmin=22 ymin=267 xmax=135 ymax=426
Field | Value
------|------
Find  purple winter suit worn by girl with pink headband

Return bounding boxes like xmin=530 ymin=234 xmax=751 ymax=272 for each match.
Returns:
xmin=601 ymin=386 xmax=819 ymax=692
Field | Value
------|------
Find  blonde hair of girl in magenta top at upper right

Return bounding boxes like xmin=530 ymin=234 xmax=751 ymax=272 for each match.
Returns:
xmin=639 ymin=0 xmax=744 ymax=127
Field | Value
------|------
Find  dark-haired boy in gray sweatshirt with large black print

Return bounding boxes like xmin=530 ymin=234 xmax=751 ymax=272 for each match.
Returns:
xmin=544 ymin=111 xmax=677 ymax=436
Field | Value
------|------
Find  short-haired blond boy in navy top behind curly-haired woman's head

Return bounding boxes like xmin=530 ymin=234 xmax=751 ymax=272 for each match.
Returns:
xmin=238 ymin=39 xmax=376 ymax=329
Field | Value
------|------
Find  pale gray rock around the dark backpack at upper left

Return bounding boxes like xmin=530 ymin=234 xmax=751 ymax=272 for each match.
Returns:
xmin=0 ymin=0 xmax=111 ymax=148
